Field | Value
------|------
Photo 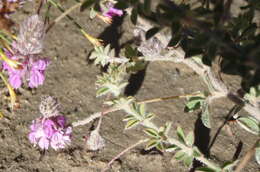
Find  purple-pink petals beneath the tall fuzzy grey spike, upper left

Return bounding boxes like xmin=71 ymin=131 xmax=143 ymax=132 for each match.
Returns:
xmin=3 ymin=52 xmax=50 ymax=89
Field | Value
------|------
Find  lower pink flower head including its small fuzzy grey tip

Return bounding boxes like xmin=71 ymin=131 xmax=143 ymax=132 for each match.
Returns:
xmin=28 ymin=96 xmax=72 ymax=150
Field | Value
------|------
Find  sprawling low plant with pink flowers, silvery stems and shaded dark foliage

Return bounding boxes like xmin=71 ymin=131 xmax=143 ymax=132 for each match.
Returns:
xmin=0 ymin=0 xmax=260 ymax=172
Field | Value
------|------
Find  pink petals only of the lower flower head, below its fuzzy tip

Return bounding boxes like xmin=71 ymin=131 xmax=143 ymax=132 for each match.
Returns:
xmin=28 ymin=115 xmax=72 ymax=150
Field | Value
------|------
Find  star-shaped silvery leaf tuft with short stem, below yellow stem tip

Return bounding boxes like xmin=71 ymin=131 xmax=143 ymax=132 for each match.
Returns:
xmin=89 ymin=44 xmax=129 ymax=66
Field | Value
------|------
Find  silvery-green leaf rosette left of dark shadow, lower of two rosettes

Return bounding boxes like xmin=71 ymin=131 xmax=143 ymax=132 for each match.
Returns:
xmin=96 ymin=64 xmax=128 ymax=97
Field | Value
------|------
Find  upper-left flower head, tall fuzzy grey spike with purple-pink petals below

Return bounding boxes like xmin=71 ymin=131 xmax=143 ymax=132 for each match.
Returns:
xmin=3 ymin=15 xmax=50 ymax=89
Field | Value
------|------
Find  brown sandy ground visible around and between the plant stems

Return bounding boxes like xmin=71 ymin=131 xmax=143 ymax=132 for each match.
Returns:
xmin=0 ymin=2 xmax=260 ymax=172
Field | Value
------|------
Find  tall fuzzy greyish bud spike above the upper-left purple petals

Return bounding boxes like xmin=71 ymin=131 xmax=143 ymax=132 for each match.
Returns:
xmin=14 ymin=15 xmax=45 ymax=55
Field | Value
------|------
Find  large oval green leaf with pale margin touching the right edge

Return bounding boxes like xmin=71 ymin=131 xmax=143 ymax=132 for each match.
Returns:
xmin=237 ymin=116 xmax=260 ymax=135
